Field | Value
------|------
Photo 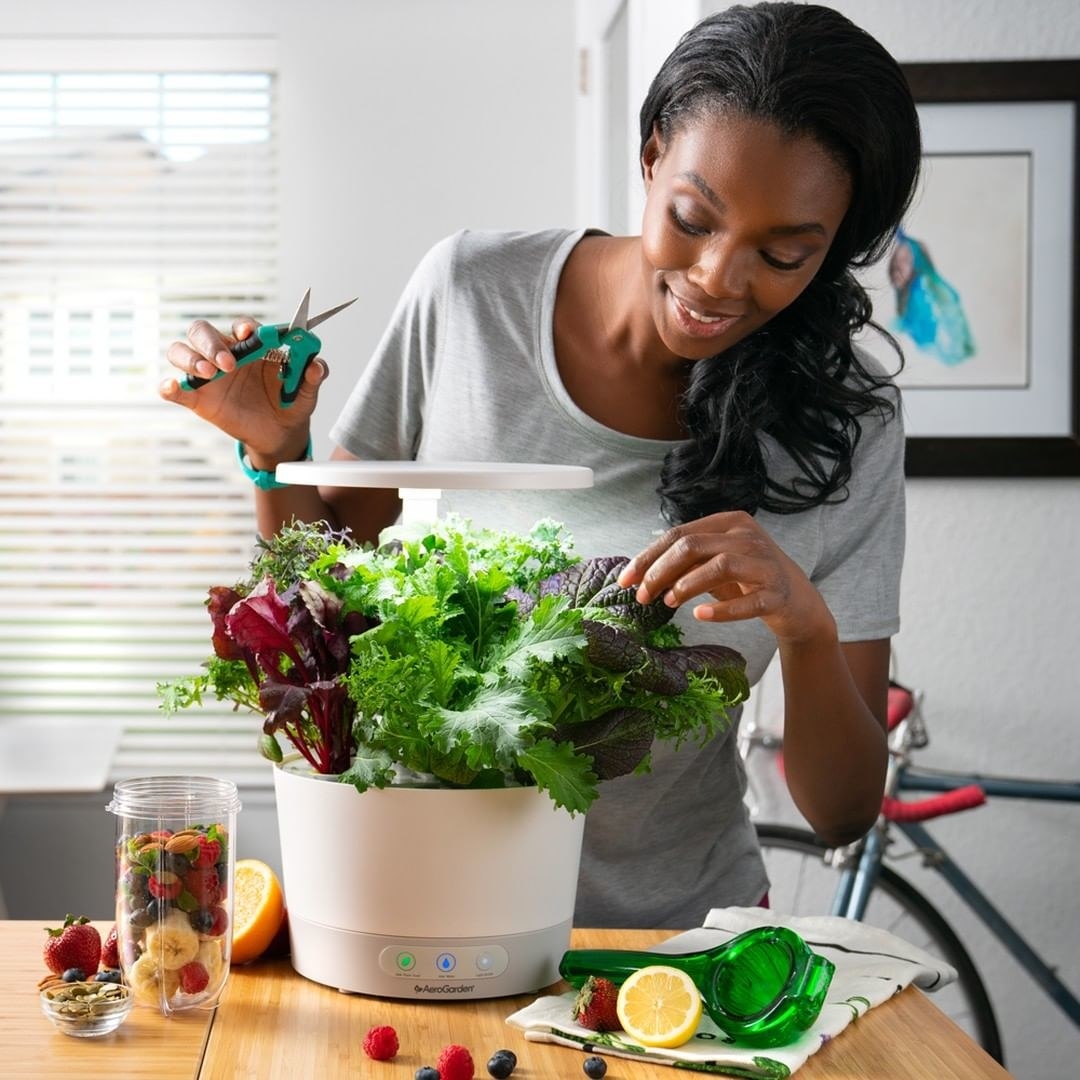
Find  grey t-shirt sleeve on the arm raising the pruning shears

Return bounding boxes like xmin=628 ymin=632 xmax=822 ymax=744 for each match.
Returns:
xmin=330 ymin=237 xmax=457 ymax=461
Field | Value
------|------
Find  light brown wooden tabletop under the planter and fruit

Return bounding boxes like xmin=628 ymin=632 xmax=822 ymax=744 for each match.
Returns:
xmin=6 ymin=921 xmax=1009 ymax=1080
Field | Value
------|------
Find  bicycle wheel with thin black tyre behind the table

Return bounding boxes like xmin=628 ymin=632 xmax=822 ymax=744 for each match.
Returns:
xmin=757 ymin=824 xmax=1004 ymax=1065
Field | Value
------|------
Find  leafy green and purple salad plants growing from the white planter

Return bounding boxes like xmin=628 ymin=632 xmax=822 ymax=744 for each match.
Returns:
xmin=161 ymin=516 xmax=747 ymax=811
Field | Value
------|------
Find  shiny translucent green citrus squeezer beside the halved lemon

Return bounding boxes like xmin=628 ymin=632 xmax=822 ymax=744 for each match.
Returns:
xmin=558 ymin=927 xmax=836 ymax=1047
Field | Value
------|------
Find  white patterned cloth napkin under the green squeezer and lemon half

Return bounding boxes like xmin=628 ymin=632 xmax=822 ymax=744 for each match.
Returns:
xmin=507 ymin=907 xmax=956 ymax=1080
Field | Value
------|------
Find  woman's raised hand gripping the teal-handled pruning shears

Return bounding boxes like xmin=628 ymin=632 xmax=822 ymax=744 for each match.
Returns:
xmin=158 ymin=318 xmax=328 ymax=469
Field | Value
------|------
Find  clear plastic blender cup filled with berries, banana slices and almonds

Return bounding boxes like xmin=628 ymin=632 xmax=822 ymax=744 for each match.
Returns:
xmin=106 ymin=777 xmax=240 ymax=1015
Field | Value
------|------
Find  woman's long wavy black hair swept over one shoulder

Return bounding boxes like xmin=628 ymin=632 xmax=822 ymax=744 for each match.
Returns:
xmin=640 ymin=3 xmax=921 ymax=523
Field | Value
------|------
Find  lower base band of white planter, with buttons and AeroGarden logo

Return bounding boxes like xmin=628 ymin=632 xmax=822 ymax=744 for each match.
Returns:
xmin=288 ymin=913 xmax=571 ymax=1001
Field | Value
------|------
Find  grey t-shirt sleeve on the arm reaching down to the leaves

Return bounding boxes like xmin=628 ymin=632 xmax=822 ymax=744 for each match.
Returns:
xmin=812 ymin=391 xmax=905 ymax=642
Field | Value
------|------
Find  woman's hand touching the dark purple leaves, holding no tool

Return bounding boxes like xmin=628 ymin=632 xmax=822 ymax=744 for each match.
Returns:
xmin=619 ymin=511 xmax=836 ymax=644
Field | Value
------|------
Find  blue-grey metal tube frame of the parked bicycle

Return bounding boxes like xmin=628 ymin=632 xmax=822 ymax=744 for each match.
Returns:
xmin=833 ymin=759 xmax=1080 ymax=1026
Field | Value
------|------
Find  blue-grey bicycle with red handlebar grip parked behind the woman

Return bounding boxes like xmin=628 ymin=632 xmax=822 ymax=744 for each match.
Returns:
xmin=740 ymin=683 xmax=1080 ymax=1065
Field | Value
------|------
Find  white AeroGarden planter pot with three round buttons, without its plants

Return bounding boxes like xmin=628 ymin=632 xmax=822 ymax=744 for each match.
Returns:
xmin=274 ymin=755 xmax=584 ymax=1000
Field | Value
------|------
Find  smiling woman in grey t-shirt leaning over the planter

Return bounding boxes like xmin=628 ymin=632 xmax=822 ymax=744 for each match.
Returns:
xmin=162 ymin=3 xmax=919 ymax=928
